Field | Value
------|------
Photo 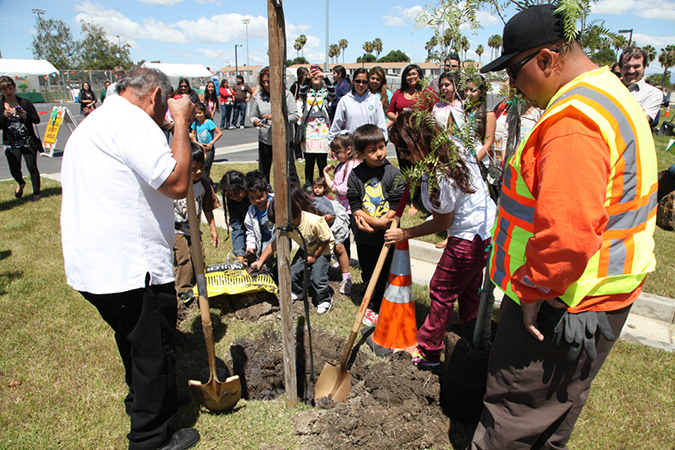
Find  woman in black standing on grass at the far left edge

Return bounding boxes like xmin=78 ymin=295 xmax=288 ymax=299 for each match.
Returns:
xmin=0 ymin=77 xmax=42 ymax=202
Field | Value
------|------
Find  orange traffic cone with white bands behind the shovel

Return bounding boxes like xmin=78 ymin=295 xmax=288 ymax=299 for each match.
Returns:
xmin=373 ymin=240 xmax=417 ymax=354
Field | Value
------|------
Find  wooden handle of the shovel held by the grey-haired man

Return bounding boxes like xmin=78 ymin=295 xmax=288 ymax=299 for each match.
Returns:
xmin=185 ymin=179 xmax=218 ymax=381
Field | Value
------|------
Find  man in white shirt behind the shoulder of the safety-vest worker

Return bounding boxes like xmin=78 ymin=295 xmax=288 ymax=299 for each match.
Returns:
xmin=619 ymin=47 xmax=663 ymax=125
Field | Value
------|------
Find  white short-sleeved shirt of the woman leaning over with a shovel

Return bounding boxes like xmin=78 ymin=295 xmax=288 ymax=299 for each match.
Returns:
xmin=421 ymin=145 xmax=497 ymax=241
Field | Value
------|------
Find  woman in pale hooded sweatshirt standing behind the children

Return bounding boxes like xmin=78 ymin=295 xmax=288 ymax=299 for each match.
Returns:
xmin=328 ymin=68 xmax=387 ymax=141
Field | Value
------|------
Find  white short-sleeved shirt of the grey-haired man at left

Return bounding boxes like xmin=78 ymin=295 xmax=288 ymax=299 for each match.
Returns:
xmin=61 ymin=95 xmax=176 ymax=294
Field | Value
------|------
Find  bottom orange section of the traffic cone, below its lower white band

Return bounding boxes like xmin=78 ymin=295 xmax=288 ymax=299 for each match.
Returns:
xmin=373 ymin=298 xmax=417 ymax=349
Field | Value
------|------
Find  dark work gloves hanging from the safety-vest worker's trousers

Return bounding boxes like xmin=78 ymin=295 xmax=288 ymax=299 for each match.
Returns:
xmin=553 ymin=310 xmax=615 ymax=361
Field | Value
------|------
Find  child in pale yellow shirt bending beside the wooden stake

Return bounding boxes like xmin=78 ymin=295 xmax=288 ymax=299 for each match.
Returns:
xmin=251 ymin=189 xmax=334 ymax=314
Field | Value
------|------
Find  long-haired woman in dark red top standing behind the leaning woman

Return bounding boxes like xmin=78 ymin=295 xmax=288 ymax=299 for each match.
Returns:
xmin=387 ymin=64 xmax=438 ymax=215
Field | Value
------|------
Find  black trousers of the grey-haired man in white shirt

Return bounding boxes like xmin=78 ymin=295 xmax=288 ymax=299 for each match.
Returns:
xmin=81 ymin=275 xmax=177 ymax=450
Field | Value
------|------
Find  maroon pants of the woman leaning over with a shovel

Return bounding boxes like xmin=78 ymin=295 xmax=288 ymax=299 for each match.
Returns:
xmin=417 ymin=235 xmax=491 ymax=361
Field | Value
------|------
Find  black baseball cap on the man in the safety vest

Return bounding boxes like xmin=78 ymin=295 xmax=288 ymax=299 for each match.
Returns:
xmin=480 ymin=4 xmax=565 ymax=73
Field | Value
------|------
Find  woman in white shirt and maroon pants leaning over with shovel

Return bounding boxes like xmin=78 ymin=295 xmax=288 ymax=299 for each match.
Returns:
xmin=384 ymin=111 xmax=496 ymax=367
